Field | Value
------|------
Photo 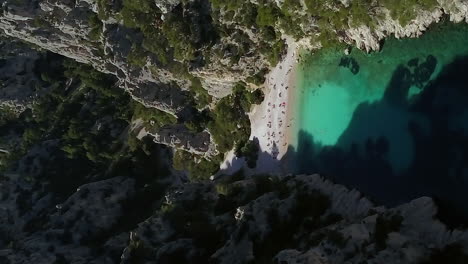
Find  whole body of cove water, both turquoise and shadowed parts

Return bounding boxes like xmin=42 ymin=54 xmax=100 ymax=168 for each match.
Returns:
xmin=290 ymin=23 xmax=468 ymax=221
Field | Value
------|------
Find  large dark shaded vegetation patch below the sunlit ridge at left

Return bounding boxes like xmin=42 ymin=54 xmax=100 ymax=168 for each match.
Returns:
xmin=0 ymin=54 xmax=176 ymax=198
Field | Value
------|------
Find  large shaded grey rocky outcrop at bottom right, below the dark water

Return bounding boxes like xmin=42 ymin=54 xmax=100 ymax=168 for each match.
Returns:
xmin=122 ymin=175 xmax=468 ymax=264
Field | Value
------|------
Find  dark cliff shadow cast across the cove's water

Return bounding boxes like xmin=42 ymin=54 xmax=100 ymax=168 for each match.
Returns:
xmin=285 ymin=56 xmax=468 ymax=225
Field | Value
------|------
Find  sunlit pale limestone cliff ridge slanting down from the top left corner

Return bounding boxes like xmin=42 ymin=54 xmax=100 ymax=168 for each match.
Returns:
xmin=0 ymin=0 xmax=188 ymax=114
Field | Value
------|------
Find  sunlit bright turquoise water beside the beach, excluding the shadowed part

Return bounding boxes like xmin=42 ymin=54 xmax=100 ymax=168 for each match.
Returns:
xmin=296 ymin=25 xmax=468 ymax=145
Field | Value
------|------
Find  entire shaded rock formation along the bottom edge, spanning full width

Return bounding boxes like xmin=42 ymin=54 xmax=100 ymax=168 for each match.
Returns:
xmin=0 ymin=175 xmax=468 ymax=264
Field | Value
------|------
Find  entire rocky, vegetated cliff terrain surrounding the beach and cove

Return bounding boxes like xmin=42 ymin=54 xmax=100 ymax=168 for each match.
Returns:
xmin=0 ymin=0 xmax=468 ymax=264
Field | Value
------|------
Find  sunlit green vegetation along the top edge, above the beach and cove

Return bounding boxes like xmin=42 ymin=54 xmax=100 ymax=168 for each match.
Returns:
xmin=210 ymin=0 xmax=437 ymax=52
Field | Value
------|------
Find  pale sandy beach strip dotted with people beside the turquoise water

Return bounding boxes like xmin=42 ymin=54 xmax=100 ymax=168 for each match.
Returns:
xmin=221 ymin=40 xmax=298 ymax=174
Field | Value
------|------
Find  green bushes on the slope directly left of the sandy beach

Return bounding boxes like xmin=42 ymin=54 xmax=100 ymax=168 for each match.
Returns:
xmin=173 ymin=83 xmax=263 ymax=181
